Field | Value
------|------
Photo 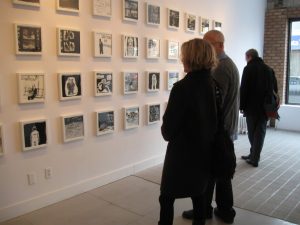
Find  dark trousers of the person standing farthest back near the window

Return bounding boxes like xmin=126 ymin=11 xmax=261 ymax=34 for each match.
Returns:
xmin=246 ymin=115 xmax=267 ymax=163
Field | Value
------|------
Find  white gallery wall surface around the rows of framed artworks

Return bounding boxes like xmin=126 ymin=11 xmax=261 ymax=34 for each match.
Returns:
xmin=0 ymin=0 xmax=266 ymax=221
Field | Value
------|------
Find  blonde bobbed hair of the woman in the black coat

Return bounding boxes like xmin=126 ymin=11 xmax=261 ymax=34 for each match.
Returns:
xmin=181 ymin=38 xmax=218 ymax=71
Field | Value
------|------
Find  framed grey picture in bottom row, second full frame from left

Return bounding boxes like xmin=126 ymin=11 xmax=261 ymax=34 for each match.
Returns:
xmin=62 ymin=114 xmax=85 ymax=142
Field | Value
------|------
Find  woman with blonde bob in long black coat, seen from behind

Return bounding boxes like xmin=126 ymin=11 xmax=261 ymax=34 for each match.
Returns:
xmin=158 ymin=38 xmax=217 ymax=225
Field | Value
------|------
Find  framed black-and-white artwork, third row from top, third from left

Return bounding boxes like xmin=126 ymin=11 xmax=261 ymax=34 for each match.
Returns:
xmin=94 ymin=71 xmax=113 ymax=96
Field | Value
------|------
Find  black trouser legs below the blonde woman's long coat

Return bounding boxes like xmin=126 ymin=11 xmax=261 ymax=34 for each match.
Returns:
xmin=158 ymin=194 xmax=205 ymax=225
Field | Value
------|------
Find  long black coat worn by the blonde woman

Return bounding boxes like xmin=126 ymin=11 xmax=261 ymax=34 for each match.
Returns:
xmin=161 ymin=70 xmax=217 ymax=198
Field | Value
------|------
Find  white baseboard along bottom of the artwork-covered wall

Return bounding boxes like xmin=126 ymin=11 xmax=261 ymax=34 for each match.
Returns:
xmin=0 ymin=155 xmax=164 ymax=222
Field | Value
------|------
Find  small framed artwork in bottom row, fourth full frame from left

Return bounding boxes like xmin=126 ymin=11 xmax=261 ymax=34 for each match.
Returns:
xmin=124 ymin=106 xmax=140 ymax=130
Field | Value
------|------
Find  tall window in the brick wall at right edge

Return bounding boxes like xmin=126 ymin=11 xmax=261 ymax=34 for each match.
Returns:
xmin=286 ymin=19 xmax=300 ymax=105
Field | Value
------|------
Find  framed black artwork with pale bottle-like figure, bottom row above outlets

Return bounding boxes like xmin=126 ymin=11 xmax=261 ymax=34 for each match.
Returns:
xmin=20 ymin=119 xmax=48 ymax=151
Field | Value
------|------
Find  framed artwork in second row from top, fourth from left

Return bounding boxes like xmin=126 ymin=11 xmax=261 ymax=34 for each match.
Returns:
xmin=122 ymin=35 xmax=139 ymax=58
